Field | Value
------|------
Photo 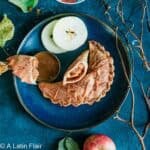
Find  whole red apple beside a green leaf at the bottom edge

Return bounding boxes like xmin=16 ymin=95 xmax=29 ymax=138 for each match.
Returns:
xmin=83 ymin=134 xmax=116 ymax=150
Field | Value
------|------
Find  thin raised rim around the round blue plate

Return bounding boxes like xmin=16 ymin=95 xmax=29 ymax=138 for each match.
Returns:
xmin=13 ymin=13 xmax=133 ymax=132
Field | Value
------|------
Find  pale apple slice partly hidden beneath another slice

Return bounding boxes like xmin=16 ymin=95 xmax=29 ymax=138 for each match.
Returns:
xmin=41 ymin=20 xmax=66 ymax=54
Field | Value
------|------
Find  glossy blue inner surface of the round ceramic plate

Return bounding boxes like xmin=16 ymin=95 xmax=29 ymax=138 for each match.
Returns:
xmin=14 ymin=14 xmax=131 ymax=131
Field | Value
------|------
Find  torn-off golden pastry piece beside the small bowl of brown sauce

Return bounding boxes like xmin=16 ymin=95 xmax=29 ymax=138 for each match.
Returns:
xmin=7 ymin=55 xmax=39 ymax=84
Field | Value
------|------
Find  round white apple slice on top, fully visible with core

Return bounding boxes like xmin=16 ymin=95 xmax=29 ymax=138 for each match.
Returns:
xmin=53 ymin=16 xmax=88 ymax=51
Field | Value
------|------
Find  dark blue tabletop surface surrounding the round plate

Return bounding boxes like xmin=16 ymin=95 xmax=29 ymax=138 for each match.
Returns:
xmin=0 ymin=0 xmax=150 ymax=150
